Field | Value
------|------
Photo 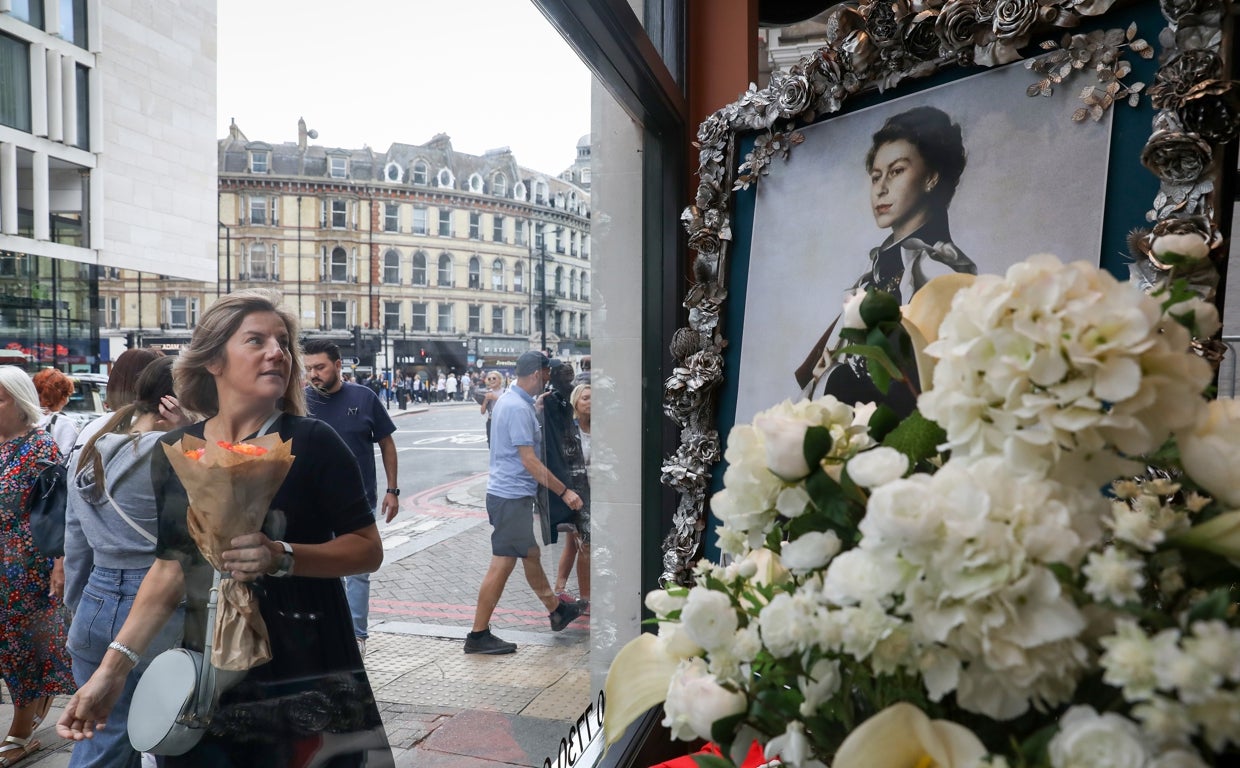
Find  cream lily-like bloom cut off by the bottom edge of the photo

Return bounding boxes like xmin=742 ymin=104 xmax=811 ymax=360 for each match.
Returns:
xmin=832 ymin=702 xmax=986 ymax=768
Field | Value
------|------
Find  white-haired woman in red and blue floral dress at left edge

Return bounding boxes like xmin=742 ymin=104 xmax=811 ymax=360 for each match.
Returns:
xmin=0 ymin=366 xmax=73 ymax=768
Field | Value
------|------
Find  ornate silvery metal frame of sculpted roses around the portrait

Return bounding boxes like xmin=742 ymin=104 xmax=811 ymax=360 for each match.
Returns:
xmin=662 ymin=0 xmax=1240 ymax=583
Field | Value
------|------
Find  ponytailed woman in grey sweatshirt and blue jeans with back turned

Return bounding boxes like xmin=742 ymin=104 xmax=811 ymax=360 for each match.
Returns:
xmin=64 ymin=357 xmax=190 ymax=768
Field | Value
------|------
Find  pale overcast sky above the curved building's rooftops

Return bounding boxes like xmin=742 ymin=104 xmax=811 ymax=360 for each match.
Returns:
xmin=218 ymin=0 xmax=590 ymax=174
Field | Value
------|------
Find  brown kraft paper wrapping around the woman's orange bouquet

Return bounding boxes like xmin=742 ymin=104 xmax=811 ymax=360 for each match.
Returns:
xmin=164 ymin=434 xmax=296 ymax=671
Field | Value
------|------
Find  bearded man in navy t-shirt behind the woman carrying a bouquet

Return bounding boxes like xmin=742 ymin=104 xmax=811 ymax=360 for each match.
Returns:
xmin=303 ymin=339 xmax=401 ymax=655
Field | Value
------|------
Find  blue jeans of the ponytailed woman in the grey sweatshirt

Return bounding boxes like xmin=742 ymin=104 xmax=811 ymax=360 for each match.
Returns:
xmin=67 ymin=567 xmax=185 ymax=768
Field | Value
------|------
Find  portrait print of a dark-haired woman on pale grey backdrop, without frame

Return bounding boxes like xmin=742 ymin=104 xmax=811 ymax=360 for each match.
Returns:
xmin=735 ymin=63 xmax=1111 ymax=423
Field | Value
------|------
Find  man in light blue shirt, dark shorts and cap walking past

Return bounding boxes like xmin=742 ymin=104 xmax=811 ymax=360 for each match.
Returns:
xmin=465 ymin=351 xmax=585 ymax=654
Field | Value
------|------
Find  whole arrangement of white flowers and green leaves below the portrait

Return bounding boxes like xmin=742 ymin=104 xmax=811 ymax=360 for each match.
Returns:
xmin=605 ymin=256 xmax=1240 ymax=768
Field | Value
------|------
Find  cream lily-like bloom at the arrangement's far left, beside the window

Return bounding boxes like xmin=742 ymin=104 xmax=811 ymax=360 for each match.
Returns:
xmin=603 ymin=633 xmax=680 ymax=746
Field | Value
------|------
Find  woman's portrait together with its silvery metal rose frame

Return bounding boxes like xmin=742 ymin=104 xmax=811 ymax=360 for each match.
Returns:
xmin=662 ymin=0 xmax=1240 ymax=583
